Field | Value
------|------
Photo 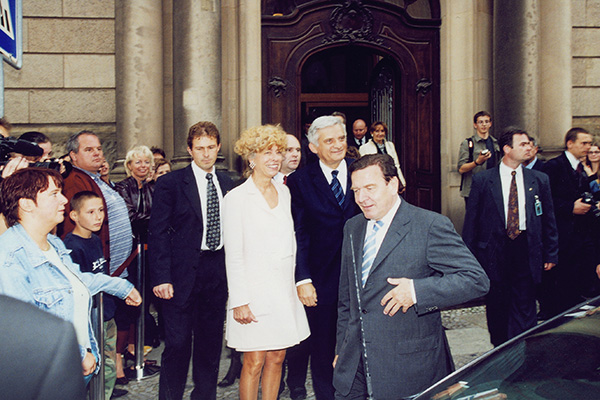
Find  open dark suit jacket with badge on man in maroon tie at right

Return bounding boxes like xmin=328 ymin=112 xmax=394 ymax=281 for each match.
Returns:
xmin=463 ymin=167 xmax=558 ymax=283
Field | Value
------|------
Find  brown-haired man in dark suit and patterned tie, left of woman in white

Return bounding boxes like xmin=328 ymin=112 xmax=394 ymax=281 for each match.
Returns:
xmin=148 ymin=121 xmax=233 ymax=400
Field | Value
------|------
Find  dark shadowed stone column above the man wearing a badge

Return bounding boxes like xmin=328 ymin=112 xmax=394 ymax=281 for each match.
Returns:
xmin=493 ymin=0 xmax=540 ymax=135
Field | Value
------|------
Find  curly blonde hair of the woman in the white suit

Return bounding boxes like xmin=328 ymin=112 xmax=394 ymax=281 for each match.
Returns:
xmin=233 ymin=124 xmax=287 ymax=176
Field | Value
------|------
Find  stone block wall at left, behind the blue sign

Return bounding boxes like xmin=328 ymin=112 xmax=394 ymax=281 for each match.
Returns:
xmin=4 ymin=0 xmax=116 ymax=161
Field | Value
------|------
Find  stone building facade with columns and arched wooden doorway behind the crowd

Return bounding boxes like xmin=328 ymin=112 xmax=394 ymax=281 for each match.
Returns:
xmin=4 ymin=0 xmax=600 ymax=228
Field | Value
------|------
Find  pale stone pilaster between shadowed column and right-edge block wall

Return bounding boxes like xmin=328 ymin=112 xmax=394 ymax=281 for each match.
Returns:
xmin=534 ymin=0 xmax=573 ymax=151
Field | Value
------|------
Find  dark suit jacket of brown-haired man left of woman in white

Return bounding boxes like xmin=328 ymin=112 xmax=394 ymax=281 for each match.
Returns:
xmin=148 ymin=165 xmax=233 ymax=304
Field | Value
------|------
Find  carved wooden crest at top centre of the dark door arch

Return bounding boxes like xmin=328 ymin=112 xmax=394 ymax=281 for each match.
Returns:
xmin=323 ymin=0 xmax=383 ymax=44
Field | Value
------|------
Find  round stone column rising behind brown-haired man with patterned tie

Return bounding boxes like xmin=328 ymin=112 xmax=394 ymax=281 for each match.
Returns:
xmin=173 ymin=0 xmax=221 ymax=158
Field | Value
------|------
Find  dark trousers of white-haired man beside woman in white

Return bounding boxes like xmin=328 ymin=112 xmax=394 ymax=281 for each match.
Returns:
xmin=306 ymin=304 xmax=337 ymax=400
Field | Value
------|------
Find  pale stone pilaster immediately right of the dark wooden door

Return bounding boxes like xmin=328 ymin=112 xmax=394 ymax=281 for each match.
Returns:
xmin=440 ymin=0 xmax=493 ymax=231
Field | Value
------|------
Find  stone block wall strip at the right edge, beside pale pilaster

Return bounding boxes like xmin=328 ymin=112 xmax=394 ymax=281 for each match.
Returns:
xmin=571 ymin=0 xmax=600 ymax=138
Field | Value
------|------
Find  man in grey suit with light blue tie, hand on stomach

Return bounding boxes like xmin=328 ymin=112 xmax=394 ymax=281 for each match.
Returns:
xmin=333 ymin=154 xmax=489 ymax=400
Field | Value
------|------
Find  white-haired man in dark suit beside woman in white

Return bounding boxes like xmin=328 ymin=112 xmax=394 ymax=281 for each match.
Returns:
xmin=287 ymin=116 xmax=358 ymax=400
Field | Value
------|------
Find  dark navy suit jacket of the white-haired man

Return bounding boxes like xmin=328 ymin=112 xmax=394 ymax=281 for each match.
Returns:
xmin=287 ymin=159 xmax=360 ymax=305
